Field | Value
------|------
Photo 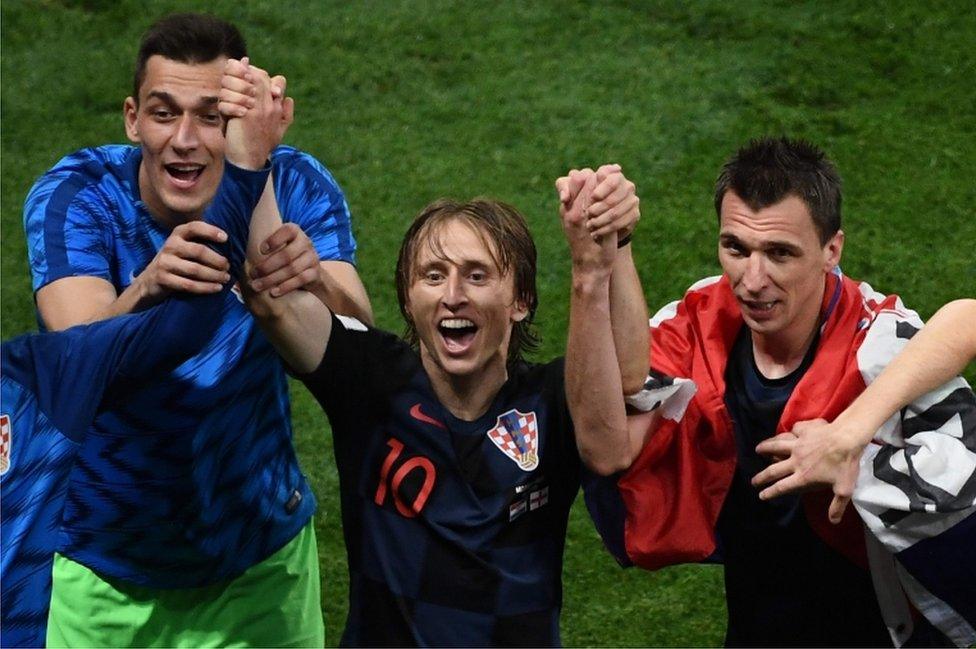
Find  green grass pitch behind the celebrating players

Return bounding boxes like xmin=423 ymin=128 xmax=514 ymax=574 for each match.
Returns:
xmin=0 ymin=0 xmax=976 ymax=646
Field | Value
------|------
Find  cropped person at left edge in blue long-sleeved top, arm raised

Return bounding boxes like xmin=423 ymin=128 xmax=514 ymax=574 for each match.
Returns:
xmin=0 ymin=129 xmax=270 ymax=647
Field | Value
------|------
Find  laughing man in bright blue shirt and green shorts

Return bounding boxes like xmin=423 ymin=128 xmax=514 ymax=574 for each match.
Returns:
xmin=24 ymin=14 xmax=370 ymax=646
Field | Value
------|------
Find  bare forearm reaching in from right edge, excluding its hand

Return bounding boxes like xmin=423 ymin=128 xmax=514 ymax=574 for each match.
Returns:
xmin=835 ymin=300 xmax=976 ymax=445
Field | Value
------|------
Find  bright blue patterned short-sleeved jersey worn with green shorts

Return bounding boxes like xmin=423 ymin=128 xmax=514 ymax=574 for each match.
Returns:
xmin=24 ymin=146 xmax=355 ymax=588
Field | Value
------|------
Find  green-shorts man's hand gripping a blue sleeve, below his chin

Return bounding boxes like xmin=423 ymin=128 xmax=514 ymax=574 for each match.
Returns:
xmin=133 ymin=221 xmax=230 ymax=307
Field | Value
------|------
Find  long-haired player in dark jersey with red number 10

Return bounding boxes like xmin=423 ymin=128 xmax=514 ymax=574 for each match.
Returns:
xmin=221 ymin=64 xmax=646 ymax=646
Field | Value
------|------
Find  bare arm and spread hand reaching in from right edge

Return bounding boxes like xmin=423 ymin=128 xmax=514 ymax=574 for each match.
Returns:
xmin=752 ymin=299 xmax=976 ymax=523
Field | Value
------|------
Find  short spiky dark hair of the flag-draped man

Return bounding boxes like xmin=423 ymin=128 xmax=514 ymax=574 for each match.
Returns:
xmin=715 ymin=137 xmax=841 ymax=245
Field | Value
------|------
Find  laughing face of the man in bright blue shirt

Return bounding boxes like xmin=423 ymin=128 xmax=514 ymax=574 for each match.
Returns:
xmin=124 ymin=55 xmax=226 ymax=226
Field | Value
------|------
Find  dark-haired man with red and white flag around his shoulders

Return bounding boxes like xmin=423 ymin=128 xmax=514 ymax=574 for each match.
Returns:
xmin=576 ymin=139 xmax=976 ymax=646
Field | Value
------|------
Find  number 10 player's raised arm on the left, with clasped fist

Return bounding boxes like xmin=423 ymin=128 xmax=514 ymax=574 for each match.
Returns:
xmin=220 ymin=60 xmax=332 ymax=373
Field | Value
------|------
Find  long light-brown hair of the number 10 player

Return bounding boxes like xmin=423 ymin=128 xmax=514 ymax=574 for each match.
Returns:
xmin=396 ymin=198 xmax=539 ymax=365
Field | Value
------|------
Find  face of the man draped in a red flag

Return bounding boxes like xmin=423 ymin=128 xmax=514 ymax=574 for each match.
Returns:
xmin=718 ymin=191 xmax=844 ymax=340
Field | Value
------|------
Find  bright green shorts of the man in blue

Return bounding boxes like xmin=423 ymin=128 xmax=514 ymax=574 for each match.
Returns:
xmin=47 ymin=521 xmax=325 ymax=647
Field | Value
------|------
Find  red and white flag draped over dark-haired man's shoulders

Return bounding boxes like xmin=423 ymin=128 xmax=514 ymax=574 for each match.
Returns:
xmin=604 ymin=270 xmax=976 ymax=646
